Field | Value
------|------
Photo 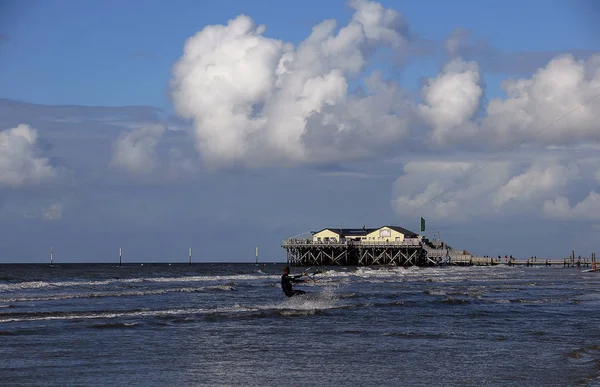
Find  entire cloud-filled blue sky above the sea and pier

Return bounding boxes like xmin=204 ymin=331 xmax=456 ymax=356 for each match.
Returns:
xmin=0 ymin=0 xmax=600 ymax=262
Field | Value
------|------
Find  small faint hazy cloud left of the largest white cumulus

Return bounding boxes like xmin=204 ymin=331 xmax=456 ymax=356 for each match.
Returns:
xmin=110 ymin=125 xmax=165 ymax=175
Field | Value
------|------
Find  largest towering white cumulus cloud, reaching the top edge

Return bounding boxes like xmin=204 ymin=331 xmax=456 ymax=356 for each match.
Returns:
xmin=171 ymin=0 xmax=412 ymax=167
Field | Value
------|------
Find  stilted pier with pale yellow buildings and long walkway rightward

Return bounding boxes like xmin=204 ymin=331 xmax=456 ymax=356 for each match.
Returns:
xmin=281 ymin=226 xmax=597 ymax=271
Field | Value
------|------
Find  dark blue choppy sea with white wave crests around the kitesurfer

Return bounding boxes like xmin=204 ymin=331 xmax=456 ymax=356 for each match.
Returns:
xmin=0 ymin=264 xmax=600 ymax=386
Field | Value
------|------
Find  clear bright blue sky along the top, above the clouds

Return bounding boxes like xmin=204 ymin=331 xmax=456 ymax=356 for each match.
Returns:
xmin=0 ymin=0 xmax=600 ymax=109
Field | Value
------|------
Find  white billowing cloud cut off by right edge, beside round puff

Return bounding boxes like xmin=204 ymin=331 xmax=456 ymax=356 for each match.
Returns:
xmin=481 ymin=54 xmax=600 ymax=146
